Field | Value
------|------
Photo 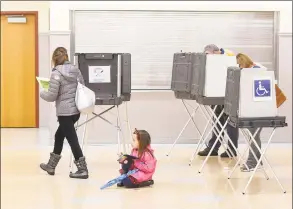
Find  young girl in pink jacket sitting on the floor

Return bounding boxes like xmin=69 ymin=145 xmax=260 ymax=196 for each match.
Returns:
xmin=117 ymin=129 xmax=157 ymax=188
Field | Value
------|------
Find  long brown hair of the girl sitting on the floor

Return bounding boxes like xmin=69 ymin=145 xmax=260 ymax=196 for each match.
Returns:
xmin=133 ymin=129 xmax=154 ymax=158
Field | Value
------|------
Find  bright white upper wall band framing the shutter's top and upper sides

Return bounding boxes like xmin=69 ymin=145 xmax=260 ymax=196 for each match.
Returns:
xmin=50 ymin=1 xmax=292 ymax=33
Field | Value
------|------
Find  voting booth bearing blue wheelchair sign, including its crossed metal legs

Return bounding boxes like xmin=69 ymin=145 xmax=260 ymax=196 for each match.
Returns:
xmin=224 ymin=67 xmax=287 ymax=194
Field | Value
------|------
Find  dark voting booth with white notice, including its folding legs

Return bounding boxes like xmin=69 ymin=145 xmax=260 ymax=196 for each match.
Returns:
xmin=70 ymin=53 xmax=131 ymax=169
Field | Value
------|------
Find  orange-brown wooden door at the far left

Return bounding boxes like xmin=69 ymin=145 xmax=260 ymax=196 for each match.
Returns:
xmin=1 ymin=13 xmax=38 ymax=128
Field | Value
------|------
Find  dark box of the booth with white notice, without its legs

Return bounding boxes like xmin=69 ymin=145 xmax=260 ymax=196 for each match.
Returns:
xmin=75 ymin=53 xmax=131 ymax=105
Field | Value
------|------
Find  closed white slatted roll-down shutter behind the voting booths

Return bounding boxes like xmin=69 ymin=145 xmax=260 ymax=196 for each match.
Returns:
xmin=72 ymin=11 xmax=275 ymax=90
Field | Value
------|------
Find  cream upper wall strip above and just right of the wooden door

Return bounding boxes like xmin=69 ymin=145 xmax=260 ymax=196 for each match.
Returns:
xmin=1 ymin=1 xmax=50 ymax=33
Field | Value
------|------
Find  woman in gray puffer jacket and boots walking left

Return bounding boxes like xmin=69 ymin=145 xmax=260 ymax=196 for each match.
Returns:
xmin=40 ymin=47 xmax=88 ymax=179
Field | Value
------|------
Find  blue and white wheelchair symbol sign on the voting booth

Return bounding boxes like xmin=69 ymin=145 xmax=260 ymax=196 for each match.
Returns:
xmin=253 ymin=79 xmax=272 ymax=101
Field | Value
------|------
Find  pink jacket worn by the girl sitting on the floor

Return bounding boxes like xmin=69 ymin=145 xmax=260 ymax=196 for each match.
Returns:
xmin=131 ymin=146 xmax=157 ymax=183
